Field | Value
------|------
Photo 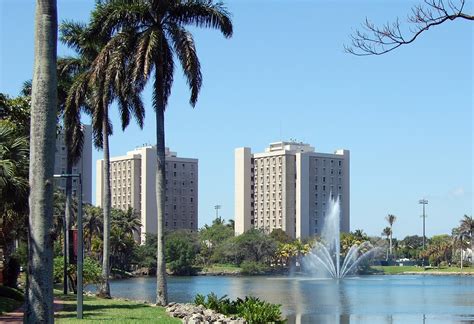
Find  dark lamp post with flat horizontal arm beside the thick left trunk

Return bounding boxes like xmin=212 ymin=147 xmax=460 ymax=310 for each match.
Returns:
xmin=53 ymin=173 xmax=84 ymax=319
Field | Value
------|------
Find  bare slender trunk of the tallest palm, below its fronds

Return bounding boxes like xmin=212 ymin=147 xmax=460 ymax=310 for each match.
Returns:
xmin=155 ymin=102 xmax=168 ymax=306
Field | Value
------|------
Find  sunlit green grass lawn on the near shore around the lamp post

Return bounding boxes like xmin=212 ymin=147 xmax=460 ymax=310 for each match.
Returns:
xmin=55 ymin=294 xmax=181 ymax=324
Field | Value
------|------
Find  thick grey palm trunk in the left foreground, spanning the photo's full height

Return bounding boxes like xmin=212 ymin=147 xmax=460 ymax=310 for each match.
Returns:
xmin=25 ymin=0 xmax=58 ymax=323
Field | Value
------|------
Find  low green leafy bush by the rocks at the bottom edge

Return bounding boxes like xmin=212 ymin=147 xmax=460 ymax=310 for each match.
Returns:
xmin=194 ymin=293 xmax=285 ymax=324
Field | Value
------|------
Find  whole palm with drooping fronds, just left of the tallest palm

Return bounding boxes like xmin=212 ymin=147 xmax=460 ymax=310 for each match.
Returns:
xmin=61 ymin=22 xmax=145 ymax=298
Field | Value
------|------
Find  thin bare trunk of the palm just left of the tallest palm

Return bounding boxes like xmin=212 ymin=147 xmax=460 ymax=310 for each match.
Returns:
xmin=99 ymin=112 xmax=111 ymax=298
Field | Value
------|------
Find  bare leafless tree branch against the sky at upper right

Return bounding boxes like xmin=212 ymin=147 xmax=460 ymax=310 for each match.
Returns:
xmin=344 ymin=0 xmax=474 ymax=56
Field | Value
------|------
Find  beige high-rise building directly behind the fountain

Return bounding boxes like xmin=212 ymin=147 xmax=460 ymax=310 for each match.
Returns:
xmin=235 ymin=142 xmax=350 ymax=238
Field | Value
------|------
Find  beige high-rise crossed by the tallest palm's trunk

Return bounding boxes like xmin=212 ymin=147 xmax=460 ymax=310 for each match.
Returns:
xmin=96 ymin=146 xmax=198 ymax=242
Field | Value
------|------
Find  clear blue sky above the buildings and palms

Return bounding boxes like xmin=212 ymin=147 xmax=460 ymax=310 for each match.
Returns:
xmin=0 ymin=0 xmax=473 ymax=238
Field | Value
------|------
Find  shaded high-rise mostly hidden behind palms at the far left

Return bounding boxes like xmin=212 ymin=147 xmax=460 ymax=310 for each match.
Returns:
xmin=54 ymin=125 xmax=92 ymax=204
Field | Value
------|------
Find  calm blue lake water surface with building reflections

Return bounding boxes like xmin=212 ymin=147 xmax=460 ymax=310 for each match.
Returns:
xmin=97 ymin=275 xmax=474 ymax=324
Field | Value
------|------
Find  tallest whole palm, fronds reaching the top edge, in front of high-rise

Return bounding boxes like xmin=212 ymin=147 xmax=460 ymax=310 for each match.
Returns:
xmin=92 ymin=0 xmax=232 ymax=305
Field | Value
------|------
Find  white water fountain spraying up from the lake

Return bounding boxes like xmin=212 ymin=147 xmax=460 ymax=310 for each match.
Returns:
xmin=302 ymin=199 xmax=378 ymax=279
